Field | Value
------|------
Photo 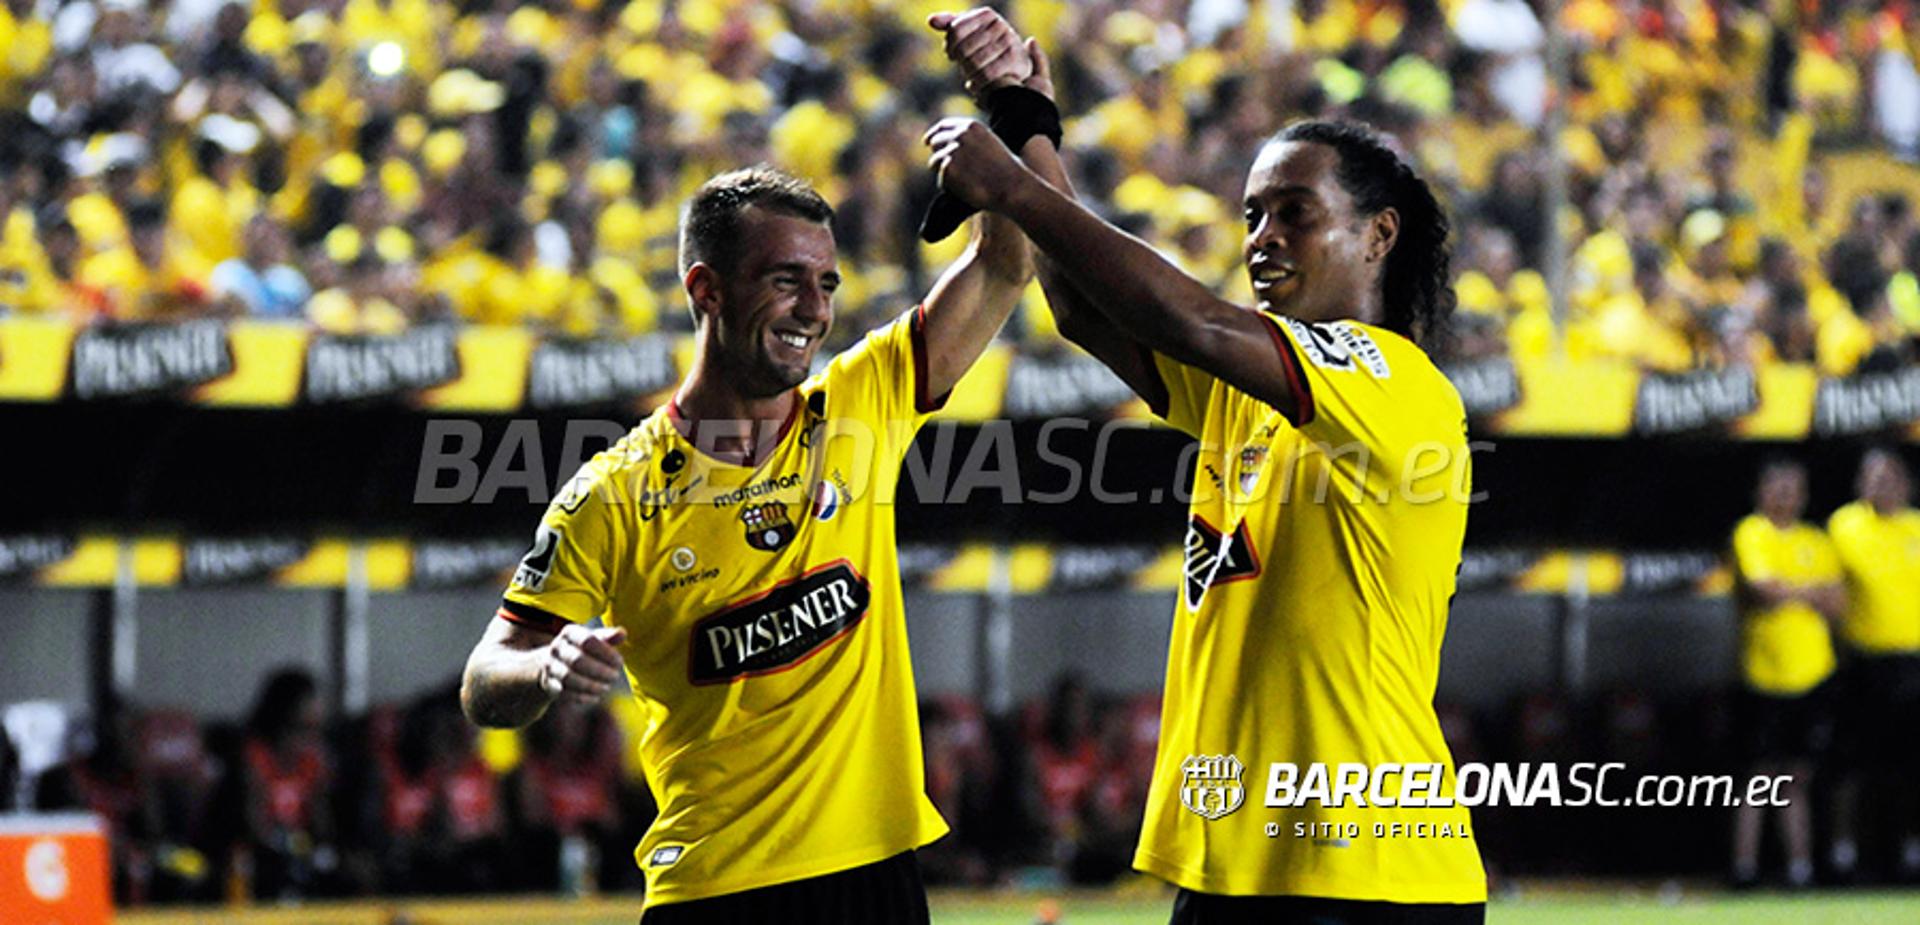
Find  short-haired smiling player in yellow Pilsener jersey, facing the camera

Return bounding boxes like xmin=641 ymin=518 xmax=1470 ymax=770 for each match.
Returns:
xmin=463 ymin=162 xmax=1044 ymax=925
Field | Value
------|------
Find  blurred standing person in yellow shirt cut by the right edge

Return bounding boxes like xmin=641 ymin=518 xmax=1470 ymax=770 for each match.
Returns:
xmin=1826 ymin=447 xmax=1920 ymax=877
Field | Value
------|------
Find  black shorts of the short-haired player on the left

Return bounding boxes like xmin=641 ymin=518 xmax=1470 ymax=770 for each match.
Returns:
xmin=639 ymin=852 xmax=929 ymax=925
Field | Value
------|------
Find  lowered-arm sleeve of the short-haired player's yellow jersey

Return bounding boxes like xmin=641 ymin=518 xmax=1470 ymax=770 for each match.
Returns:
xmin=499 ymin=459 xmax=628 ymax=631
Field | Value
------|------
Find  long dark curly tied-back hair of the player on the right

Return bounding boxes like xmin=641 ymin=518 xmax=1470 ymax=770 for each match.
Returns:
xmin=1269 ymin=121 xmax=1453 ymax=349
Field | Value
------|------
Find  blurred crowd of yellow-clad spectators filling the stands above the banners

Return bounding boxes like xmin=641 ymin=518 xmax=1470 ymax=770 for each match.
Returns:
xmin=0 ymin=0 xmax=1920 ymax=374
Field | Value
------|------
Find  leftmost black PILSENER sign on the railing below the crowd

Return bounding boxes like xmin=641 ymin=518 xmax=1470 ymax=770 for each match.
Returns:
xmin=73 ymin=320 xmax=234 ymax=399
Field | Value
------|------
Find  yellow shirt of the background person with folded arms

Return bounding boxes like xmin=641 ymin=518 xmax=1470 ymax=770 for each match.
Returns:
xmin=1734 ymin=514 xmax=1841 ymax=697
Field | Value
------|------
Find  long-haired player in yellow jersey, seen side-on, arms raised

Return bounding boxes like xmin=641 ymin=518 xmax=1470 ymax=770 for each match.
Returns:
xmin=927 ymin=9 xmax=1486 ymax=923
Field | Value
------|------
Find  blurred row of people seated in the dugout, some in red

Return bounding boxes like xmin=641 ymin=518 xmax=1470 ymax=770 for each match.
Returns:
xmin=0 ymin=670 xmax=1732 ymax=906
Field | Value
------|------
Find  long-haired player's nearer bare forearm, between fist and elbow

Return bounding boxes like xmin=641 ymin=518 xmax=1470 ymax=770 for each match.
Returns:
xmin=998 ymin=175 xmax=1240 ymax=365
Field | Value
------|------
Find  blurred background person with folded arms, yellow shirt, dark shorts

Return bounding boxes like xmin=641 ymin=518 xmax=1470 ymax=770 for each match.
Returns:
xmin=1734 ymin=461 xmax=1847 ymax=887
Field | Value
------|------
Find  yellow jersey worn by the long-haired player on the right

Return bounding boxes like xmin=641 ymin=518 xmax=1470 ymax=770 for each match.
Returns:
xmin=1135 ymin=313 xmax=1486 ymax=904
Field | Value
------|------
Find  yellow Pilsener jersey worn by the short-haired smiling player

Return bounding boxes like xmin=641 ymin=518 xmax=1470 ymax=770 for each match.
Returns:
xmin=501 ymin=309 xmax=947 ymax=906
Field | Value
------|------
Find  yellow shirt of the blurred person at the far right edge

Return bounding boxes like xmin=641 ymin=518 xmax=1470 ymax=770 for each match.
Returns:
xmin=1826 ymin=501 xmax=1920 ymax=654
